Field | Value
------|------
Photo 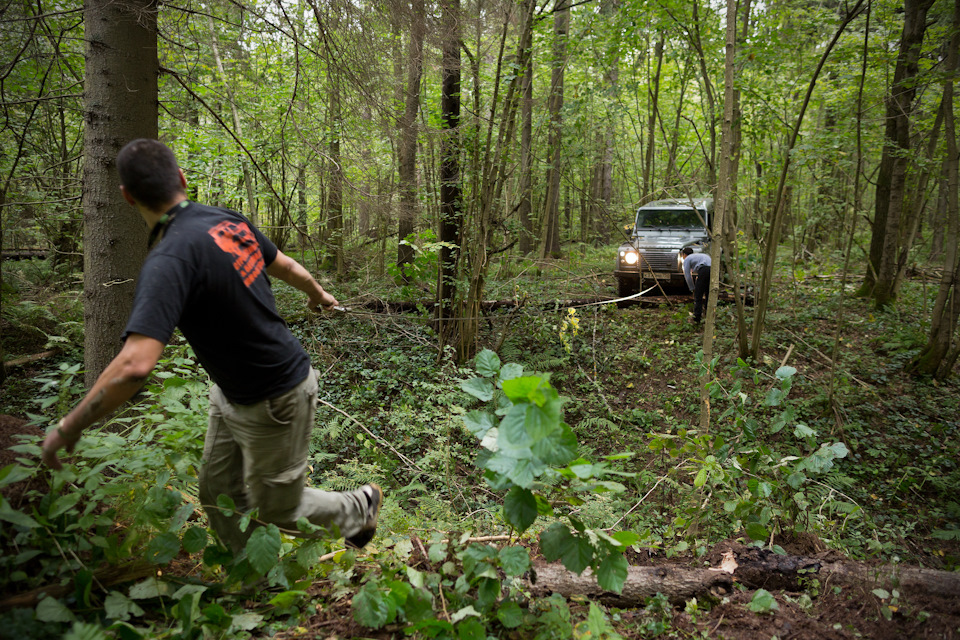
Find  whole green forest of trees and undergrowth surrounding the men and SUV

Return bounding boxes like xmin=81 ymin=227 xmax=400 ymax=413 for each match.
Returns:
xmin=0 ymin=0 xmax=960 ymax=638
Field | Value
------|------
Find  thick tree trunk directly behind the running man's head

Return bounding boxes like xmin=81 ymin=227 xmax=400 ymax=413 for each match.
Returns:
xmin=82 ymin=0 xmax=160 ymax=387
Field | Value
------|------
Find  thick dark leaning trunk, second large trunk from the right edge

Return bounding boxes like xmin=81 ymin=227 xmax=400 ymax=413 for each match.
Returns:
xmin=860 ymin=0 xmax=934 ymax=308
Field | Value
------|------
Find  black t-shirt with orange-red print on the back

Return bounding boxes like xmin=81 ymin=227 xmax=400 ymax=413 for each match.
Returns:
xmin=123 ymin=202 xmax=310 ymax=404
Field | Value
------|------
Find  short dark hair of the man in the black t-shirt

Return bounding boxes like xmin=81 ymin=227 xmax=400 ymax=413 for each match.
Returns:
xmin=117 ymin=138 xmax=183 ymax=209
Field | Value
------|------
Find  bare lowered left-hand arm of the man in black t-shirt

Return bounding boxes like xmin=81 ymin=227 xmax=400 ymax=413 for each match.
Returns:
xmin=42 ymin=333 xmax=164 ymax=469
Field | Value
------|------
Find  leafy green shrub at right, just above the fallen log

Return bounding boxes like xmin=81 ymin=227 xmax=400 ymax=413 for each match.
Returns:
xmin=649 ymin=360 xmax=863 ymax=549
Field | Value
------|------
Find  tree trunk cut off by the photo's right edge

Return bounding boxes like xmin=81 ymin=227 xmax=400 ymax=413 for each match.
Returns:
xmin=907 ymin=0 xmax=960 ymax=379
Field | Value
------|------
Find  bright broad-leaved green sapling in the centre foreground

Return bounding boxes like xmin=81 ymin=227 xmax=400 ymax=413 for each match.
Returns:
xmin=462 ymin=350 xmax=638 ymax=592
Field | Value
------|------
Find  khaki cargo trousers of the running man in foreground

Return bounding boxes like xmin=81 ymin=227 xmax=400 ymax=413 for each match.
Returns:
xmin=199 ymin=370 xmax=367 ymax=553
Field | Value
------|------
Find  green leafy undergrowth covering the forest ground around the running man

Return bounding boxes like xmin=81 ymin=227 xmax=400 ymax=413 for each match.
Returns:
xmin=0 ymin=250 xmax=960 ymax=638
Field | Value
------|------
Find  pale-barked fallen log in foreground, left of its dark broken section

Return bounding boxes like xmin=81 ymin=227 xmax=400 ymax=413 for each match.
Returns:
xmin=530 ymin=564 xmax=734 ymax=608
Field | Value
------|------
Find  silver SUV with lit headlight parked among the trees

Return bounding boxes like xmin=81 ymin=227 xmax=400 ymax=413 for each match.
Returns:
xmin=613 ymin=198 xmax=713 ymax=297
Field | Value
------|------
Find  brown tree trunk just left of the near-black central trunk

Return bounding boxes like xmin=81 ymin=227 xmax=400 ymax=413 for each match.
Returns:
xmin=397 ymin=0 xmax=426 ymax=280
